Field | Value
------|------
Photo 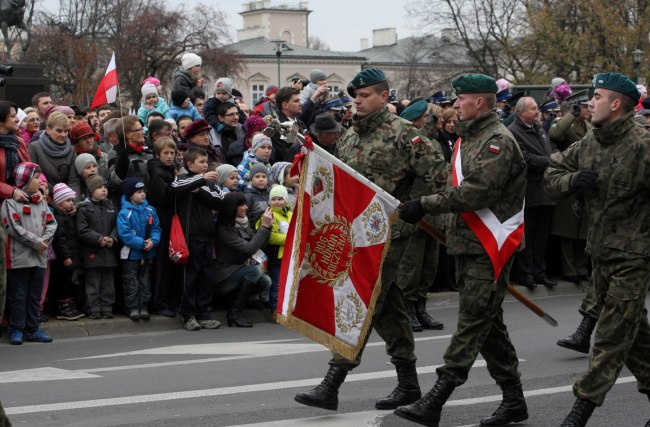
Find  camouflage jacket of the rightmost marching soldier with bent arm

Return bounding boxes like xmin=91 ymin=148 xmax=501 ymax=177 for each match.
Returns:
xmin=544 ymin=113 xmax=650 ymax=260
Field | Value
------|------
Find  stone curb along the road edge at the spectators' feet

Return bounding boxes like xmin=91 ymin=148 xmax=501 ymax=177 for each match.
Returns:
xmin=36 ymin=281 xmax=583 ymax=339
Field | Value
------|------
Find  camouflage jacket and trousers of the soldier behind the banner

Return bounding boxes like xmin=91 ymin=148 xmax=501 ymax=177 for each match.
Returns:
xmin=330 ymin=108 xmax=447 ymax=369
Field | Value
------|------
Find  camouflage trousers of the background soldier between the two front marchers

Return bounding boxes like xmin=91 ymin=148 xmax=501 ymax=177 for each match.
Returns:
xmin=397 ymin=229 xmax=440 ymax=302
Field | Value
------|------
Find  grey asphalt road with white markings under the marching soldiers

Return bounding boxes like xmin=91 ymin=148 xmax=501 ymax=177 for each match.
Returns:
xmin=0 ymin=295 xmax=650 ymax=427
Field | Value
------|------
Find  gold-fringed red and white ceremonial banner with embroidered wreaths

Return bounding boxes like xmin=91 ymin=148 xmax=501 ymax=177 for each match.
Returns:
xmin=277 ymin=146 xmax=399 ymax=359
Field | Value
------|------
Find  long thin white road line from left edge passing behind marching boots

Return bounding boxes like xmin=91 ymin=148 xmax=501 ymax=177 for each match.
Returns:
xmin=5 ymin=360 xmax=486 ymax=415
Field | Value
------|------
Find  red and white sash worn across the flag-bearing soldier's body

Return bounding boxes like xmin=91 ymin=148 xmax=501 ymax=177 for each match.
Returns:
xmin=451 ymin=138 xmax=524 ymax=282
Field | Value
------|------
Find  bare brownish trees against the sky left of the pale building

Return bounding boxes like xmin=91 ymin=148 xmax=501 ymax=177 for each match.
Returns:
xmin=22 ymin=0 xmax=241 ymax=105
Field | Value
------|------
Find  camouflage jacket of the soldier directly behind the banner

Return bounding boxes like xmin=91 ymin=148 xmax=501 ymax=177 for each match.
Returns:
xmin=336 ymin=108 xmax=447 ymax=238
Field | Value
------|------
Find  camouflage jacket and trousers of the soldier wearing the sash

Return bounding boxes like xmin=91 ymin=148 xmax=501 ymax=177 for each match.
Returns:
xmin=421 ymin=112 xmax=527 ymax=386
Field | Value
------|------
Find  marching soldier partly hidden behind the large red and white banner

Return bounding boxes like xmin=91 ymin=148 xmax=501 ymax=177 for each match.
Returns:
xmin=295 ymin=68 xmax=447 ymax=410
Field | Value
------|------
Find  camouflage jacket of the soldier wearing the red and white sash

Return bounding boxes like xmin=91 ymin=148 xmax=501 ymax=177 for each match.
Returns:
xmin=421 ymin=112 xmax=527 ymax=255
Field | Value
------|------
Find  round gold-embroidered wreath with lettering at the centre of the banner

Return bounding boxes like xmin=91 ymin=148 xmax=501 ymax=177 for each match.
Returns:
xmin=303 ymin=215 xmax=354 ymax=288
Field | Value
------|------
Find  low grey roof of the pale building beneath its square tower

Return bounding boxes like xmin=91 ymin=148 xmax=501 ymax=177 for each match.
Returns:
xmin=226 ymin=37 xmax=366 ymax=61
